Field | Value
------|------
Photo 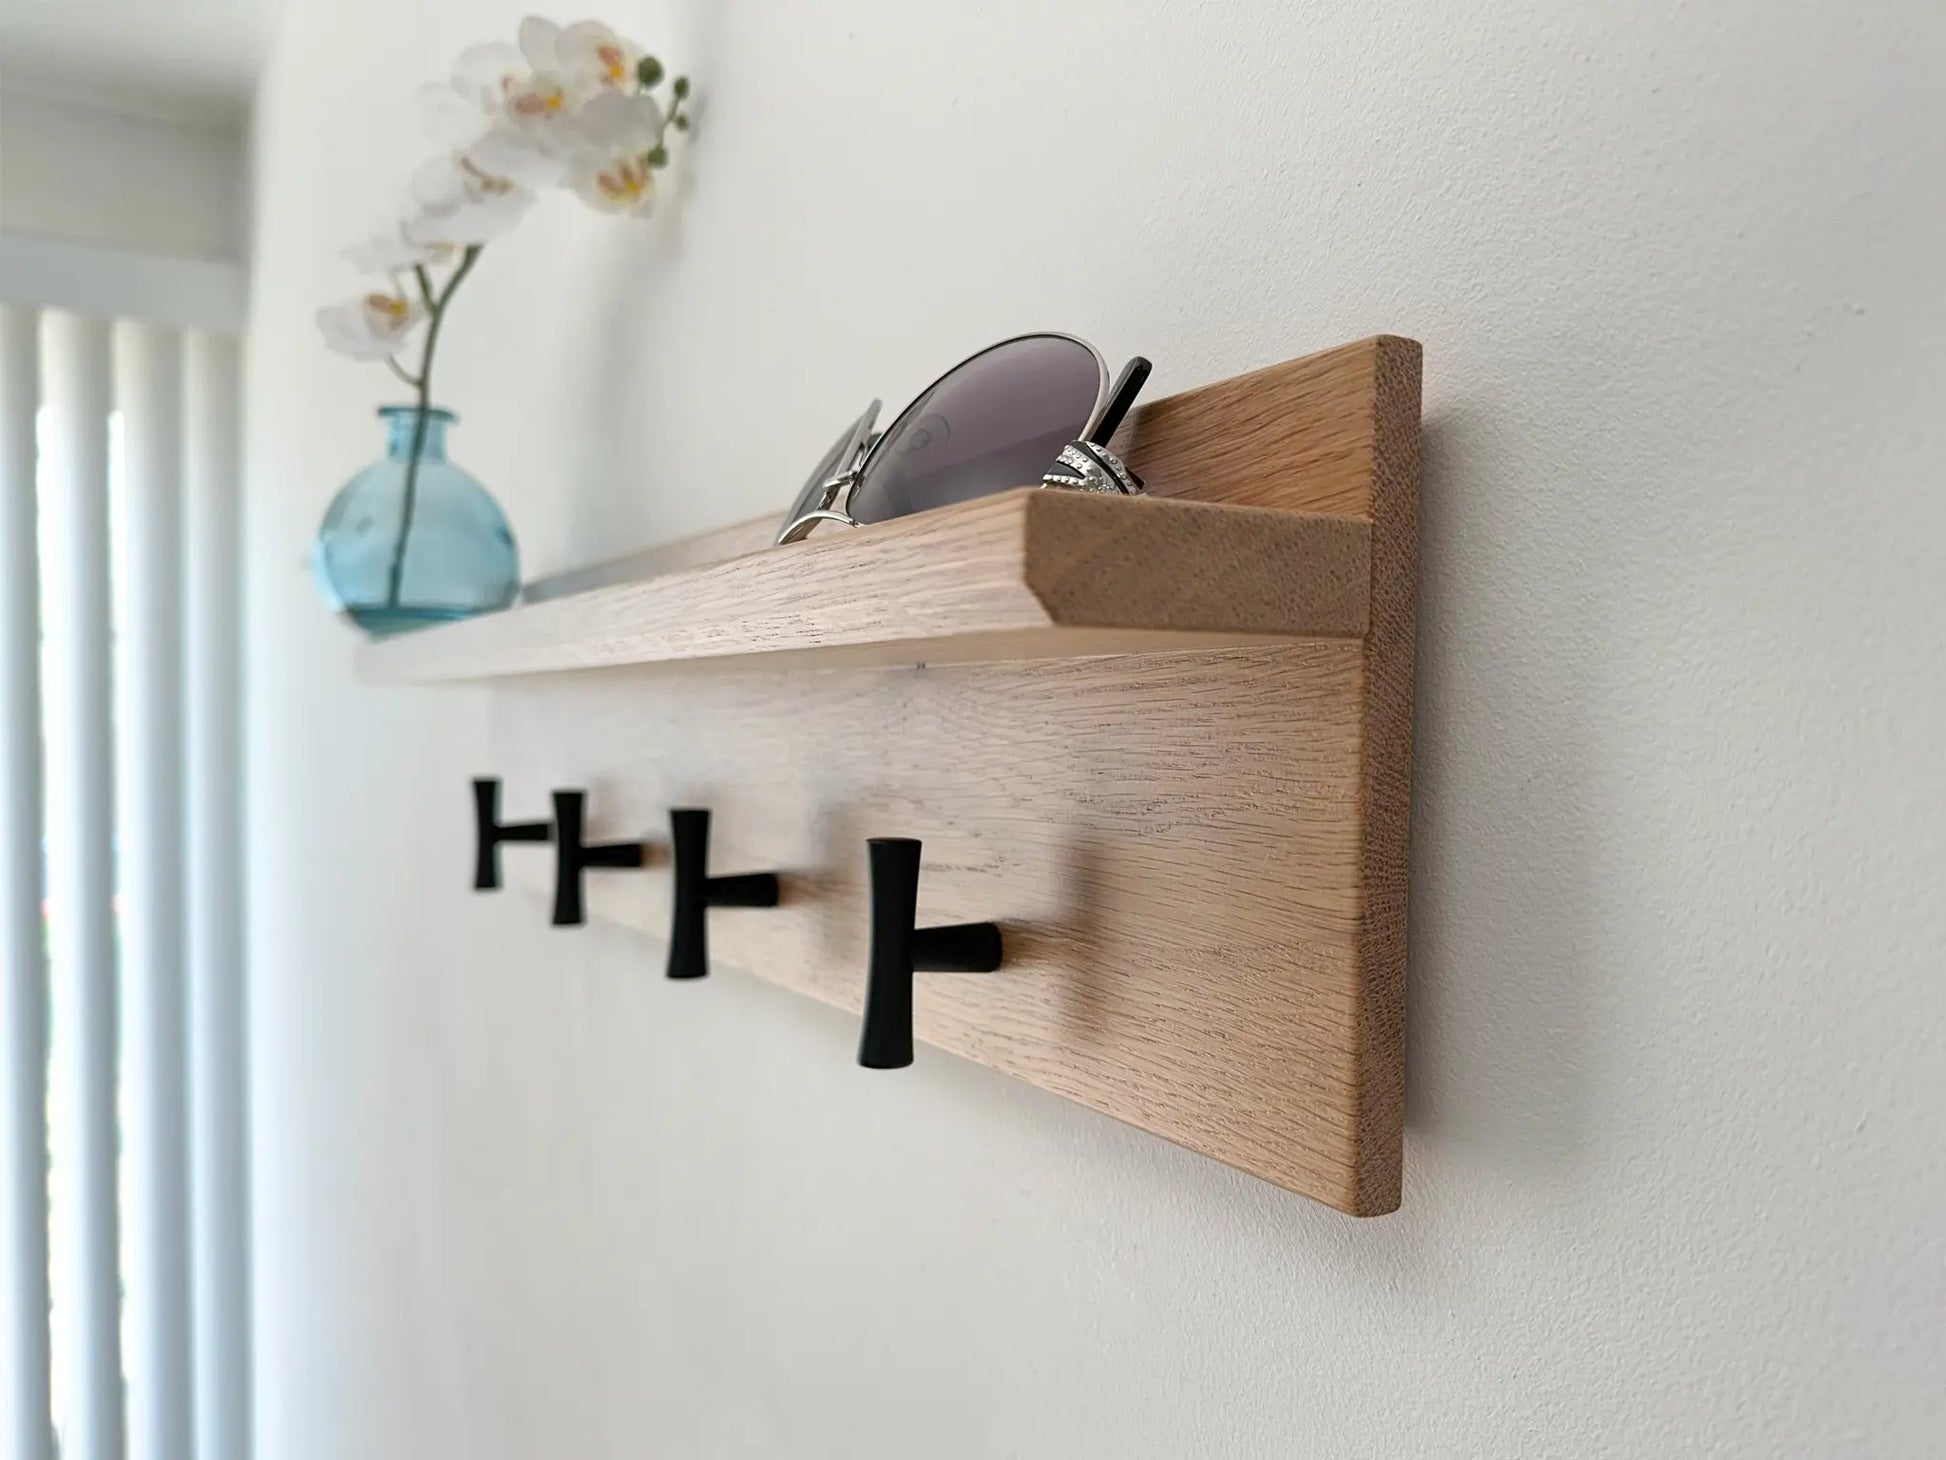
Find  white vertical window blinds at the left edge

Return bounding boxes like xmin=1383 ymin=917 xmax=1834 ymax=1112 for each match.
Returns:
xmin=0 ymin=306 xmax=249 ymax=1460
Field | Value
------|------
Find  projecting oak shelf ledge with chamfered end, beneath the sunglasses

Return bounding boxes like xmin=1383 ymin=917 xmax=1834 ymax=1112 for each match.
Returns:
xmin=362 ymin=489 xmax=1372 ymax=681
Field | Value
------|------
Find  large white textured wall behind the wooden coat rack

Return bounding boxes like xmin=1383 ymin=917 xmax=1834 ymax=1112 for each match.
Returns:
xmin=247 ymin=0 xmax=1946 ymax=1460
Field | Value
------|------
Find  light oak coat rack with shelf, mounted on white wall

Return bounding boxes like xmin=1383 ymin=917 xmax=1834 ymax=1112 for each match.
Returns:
xmin=362 ymin=337 xmax=1419 ymax=1215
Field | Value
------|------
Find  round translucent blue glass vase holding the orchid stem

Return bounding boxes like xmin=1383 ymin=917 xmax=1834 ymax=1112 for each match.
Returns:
xmin=311 ymin=405 xmax=520 ymax=639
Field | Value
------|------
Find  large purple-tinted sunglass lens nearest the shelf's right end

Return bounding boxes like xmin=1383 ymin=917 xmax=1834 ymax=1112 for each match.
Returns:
xmin=850 ymin=335 xmax=1101 ymax=522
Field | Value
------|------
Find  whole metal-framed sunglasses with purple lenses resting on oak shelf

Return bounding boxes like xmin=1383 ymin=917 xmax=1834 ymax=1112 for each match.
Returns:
xmin=776 ymin=333 xmax=1150 ymax=543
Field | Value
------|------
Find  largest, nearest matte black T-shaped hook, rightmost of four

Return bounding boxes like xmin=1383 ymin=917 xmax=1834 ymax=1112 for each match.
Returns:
xmin=858 ymin=837 xmax=1000 ymax=1069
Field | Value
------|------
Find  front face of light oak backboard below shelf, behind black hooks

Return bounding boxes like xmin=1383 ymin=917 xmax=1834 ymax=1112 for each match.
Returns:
xmin=494 ymin=640 xmax=1369 ymax=1211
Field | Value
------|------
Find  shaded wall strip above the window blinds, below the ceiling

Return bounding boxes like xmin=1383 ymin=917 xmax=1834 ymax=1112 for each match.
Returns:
xmin=0 ymin=91 xmax=245 ymax=259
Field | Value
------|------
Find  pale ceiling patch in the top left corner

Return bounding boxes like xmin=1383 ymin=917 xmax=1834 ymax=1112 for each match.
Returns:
xmin=0 ymin=0 xmax=282 ymax=121
